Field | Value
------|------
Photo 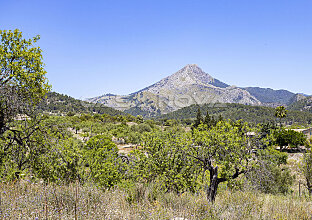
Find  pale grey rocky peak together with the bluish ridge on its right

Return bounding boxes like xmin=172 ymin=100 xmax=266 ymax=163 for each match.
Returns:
xmin=87 ymin=64 xmax=308 ymax=116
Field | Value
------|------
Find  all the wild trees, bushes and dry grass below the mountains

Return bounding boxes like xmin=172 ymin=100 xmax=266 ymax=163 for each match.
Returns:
xmin=0 ymin=30 xmax=312 ymax=219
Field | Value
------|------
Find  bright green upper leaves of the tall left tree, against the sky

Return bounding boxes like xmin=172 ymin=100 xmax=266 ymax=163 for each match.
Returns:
xmin=0 ymin=29 xmax=50 ymax=104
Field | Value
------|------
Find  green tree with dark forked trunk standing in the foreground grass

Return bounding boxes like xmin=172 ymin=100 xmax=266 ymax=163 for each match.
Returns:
xmin=186 ymin=121 xmax=258 ymax=202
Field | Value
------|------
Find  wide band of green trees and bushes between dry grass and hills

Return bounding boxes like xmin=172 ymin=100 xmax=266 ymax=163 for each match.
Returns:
xmin=0 ymin=102 xmax=298 ymax=201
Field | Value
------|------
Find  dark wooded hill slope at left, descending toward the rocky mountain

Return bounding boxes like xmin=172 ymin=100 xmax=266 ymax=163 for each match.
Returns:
xmin=38 ymin=92 xmax=124 ymax=116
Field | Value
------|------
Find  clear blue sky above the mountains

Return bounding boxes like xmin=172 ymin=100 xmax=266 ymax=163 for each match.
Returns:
xmin=0 ymin=0 xmax=312 ymax=98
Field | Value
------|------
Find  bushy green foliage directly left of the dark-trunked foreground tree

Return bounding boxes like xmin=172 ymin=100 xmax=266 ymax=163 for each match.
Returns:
xmin=131 ymin=132 xmax=199 ymax=192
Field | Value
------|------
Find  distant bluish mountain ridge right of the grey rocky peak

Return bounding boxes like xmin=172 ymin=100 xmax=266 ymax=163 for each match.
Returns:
xmin=243 ymin=87 xmax=295 ymax=107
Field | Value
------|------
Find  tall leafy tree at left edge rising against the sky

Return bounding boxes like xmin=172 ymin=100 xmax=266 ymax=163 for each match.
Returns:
xmin=0 ymin=29 xmax=50 ymax=134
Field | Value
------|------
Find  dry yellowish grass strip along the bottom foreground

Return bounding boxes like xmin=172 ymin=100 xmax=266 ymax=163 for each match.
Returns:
xmin=0 ymin=182 xmax=312 ymax=220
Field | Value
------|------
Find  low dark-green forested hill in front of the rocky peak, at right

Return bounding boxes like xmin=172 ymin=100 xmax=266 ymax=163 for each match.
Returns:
xmin=157 ymin=103 xmax=312 ymax=124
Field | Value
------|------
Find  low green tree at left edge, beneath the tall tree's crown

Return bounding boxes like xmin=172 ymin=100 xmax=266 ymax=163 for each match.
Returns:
xmin=0 ymin=116 xmax=69 ymax=180
